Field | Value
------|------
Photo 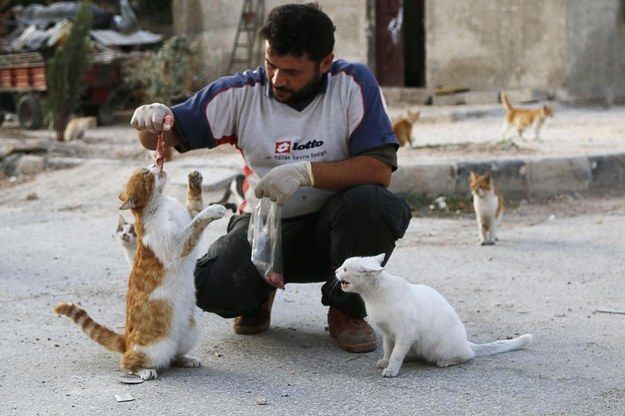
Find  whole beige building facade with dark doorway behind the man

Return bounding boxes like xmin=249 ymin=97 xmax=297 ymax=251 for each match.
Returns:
xmin=173 ymin=0 xmax=625 ymax=104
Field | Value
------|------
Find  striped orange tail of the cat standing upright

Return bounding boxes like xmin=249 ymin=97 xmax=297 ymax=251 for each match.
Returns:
xmin=54 ymin=302 xmax=126 ymax=353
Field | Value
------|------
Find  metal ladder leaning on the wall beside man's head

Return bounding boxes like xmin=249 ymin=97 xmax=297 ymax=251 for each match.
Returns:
xmin=228 ymin=0 xmax=265 ymax=73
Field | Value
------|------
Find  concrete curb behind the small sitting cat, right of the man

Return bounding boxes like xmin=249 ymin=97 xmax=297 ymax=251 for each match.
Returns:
xmin=390 ymin=153 xmax=625 ymax=199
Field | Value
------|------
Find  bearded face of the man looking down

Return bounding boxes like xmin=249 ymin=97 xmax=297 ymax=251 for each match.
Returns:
xmin=265 ymin=42 xmax=334 ymax=103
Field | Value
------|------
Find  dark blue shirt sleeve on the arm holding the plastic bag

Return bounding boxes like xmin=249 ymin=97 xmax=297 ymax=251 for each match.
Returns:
xmin=344 ymin=63 xmax=399 ymax=156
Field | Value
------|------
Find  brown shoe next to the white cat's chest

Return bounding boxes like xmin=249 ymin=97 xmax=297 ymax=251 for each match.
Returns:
xmin=328 ymin=306 xmax=378 ymax=352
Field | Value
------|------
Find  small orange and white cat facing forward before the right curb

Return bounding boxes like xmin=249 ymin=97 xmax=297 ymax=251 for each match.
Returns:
xmin=469 ymin=172 xmax=504 ymax=246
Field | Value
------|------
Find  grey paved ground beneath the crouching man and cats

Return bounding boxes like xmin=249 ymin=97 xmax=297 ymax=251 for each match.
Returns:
xmin=0 ymin=105 xmax=625 ymax=415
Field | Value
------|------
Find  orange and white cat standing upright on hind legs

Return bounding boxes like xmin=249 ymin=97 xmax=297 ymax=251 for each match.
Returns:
xmin=54 ymin=165 xmax=226 ymax=381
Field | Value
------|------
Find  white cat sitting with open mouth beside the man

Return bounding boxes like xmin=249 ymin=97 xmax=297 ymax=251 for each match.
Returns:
xmin=336 ymin=254 xmax=533 ymax=377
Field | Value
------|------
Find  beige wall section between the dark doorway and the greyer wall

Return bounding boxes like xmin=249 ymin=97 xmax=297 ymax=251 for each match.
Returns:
xmin=425 ymin=0 xmax=564 ymax=90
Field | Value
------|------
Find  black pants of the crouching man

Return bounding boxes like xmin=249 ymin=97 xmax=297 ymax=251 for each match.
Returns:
xmin=195 ymin=185 xmax=411 ymax=318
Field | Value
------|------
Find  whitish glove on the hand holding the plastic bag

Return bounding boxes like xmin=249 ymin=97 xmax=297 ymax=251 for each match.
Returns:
xmin=254 ymin=162 xmax=315 ymax=206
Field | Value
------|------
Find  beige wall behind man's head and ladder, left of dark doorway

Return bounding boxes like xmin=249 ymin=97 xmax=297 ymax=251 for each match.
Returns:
xmin=173 ymin=0 xmax=368 ymax=86
